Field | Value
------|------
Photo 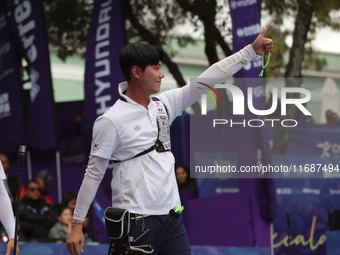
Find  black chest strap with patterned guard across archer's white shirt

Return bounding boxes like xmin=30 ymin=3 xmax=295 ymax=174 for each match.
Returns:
xmin=113 ymin=97 xmax=171 ymax=163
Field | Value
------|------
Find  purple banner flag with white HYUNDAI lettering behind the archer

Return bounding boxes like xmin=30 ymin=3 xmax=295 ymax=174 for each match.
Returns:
xmin=85 ymin=0 xmax=124 ymax=134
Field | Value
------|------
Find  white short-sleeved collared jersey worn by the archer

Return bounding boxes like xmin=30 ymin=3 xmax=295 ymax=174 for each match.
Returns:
xmin=91 ymin=82 xmax=183 ymax=215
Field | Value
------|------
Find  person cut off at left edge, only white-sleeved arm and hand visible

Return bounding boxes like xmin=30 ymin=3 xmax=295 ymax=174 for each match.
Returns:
xmin=0 ymin=161 xmax=20 ymax=255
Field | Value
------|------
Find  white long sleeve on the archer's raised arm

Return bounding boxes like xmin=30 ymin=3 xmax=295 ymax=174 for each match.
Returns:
xmin=181 ymin=44 xmax=257 ymax=110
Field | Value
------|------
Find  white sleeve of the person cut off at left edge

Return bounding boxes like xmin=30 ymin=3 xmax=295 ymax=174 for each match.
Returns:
xmin=0 ymin=180 xmax=15 ymax=239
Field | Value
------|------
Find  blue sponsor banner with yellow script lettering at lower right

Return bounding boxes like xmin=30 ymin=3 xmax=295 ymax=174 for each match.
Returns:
xmin=269 ymin=121 xmax=340 ymax=255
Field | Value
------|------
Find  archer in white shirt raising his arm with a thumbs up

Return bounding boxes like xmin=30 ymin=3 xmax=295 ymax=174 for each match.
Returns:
xmin=66 ymin=28 xmax=273 ymax=255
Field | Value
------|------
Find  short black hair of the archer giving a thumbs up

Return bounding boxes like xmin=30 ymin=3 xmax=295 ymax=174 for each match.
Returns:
xmin=119 ymin=43 xmax=164 ymax=82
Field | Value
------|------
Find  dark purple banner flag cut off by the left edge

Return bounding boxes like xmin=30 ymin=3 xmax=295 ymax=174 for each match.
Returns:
xmin=0 ymin=1 xmax=26 ymax=153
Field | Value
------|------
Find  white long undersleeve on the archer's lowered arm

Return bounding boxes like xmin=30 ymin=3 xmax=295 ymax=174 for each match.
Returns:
xmin=73 ymin=156 xmax=109 ymax=221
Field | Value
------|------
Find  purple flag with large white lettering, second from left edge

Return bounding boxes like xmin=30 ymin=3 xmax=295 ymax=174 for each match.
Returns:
xmin=11 ymin=0 xmax=56 ymax=150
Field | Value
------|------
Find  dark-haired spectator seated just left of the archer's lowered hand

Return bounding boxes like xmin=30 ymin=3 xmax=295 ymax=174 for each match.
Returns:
xmin=48 ymin=206 xmax=72 ymax=241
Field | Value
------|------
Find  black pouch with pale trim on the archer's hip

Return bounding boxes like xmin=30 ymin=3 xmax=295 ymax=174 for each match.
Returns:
xmin=104 ymin=207 xmax=130 ymax=239
